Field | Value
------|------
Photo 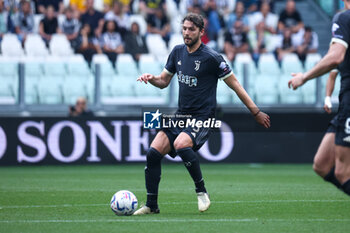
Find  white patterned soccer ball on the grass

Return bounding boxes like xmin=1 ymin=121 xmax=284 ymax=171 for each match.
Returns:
xmin=111 ymin=190 xmax=138 ymax=216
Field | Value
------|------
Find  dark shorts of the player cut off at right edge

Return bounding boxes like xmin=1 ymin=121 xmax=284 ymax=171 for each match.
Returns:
xmin=327 ymin=92 xmax=350 ymax=147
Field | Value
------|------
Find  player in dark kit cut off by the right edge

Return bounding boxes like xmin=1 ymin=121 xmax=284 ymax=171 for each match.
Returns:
xmin=288 ymin=0 xmax=350 ymax=195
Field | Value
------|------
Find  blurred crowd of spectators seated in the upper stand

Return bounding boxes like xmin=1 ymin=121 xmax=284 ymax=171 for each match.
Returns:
xmin=0 ymin=0 xmax=318 ymax=68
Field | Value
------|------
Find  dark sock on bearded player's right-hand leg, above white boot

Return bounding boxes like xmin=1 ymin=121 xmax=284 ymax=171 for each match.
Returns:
xmin=176 ymin=147 xmax=207 ymax=193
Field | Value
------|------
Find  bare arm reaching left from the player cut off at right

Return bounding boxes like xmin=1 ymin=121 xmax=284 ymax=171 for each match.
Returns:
xmin=288 ymin=43 xmax=346 ymax=90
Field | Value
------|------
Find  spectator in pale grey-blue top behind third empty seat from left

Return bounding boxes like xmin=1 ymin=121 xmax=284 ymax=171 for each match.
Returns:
xmin=60 ymin=7 xmax=80 ymax=51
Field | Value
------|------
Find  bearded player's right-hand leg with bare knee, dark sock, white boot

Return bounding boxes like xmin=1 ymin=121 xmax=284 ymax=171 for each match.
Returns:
xmin=174 ymin=132 xmax=210 ymax=212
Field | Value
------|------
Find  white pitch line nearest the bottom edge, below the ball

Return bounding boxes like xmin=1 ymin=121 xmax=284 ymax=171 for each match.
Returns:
xmin=0 ymin=217 xmax=350 ymax=224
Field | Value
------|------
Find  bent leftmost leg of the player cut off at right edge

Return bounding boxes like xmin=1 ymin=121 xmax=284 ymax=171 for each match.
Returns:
xmin=313 ymin=133 xmax=341 ymax=189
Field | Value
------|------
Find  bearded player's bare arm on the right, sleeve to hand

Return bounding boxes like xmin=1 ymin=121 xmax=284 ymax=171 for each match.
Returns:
xmin=225 ymin=74 xmax=270 ymax=128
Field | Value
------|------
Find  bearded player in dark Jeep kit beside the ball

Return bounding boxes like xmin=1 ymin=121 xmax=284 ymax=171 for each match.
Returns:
xmin=134 ymin=13 xmax=270 ymax=215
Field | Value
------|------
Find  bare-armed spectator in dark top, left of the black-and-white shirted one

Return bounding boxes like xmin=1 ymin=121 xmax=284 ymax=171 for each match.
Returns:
xmin=77 ymin=24 xmax=102 ymax=66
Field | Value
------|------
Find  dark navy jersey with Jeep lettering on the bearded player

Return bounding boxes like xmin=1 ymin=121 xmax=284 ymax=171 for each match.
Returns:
xmin=165 ymin=44 xmax=232 ymax=114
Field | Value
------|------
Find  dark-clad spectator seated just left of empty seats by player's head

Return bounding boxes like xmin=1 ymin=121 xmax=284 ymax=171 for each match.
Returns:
xmin=125 ymin=22 xmax=148 ymax=67
